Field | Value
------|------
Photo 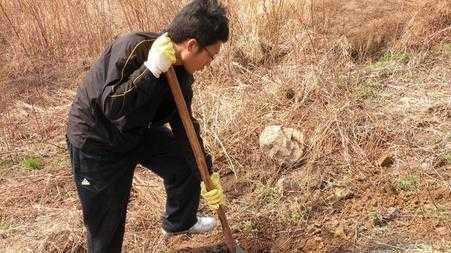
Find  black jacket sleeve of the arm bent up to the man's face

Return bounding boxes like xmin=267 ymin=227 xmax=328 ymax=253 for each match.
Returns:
xmin=99 ymin=37 xmax=161 ymax=121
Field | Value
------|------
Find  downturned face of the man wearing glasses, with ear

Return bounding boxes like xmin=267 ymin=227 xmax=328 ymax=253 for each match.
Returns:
xmin=181 ymin=39 xmax=222 ymax=74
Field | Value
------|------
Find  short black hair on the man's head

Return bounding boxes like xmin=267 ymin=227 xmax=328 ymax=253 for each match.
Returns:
xmin=167 ymin=0 xmax=229 ymax=48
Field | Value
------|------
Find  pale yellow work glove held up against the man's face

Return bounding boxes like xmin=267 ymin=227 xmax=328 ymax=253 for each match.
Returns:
xmin=144 ymin=33 xmax=176 ymax=78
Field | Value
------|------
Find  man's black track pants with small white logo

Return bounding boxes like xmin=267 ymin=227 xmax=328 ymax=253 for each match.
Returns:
xmin=68 ymin=127 xmax=200 ymax=253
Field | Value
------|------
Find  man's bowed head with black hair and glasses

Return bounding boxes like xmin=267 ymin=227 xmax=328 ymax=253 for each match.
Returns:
xmin=167 ymin=0 xmax=229 ymax=73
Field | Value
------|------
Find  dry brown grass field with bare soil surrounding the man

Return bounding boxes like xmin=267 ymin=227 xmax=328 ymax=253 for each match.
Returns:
xmin=0 ymin=0 xmax=451 ymax=253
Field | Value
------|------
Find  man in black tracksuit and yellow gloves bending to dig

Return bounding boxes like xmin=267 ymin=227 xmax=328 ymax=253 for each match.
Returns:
xmin=67 ymin=0 xmax=229 ymax=252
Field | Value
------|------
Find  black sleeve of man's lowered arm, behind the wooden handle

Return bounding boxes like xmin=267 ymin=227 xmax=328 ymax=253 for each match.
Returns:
xmin=169 ymin=97 xmax=213 ymax=175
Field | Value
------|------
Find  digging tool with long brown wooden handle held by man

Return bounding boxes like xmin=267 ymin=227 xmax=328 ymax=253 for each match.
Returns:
xmin=166 ymin=67 xmax=245 ymax=253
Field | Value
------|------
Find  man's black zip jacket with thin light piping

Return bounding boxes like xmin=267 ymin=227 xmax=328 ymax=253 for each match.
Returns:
xmin=67 ymin=32 xmax=211 ymax=169
